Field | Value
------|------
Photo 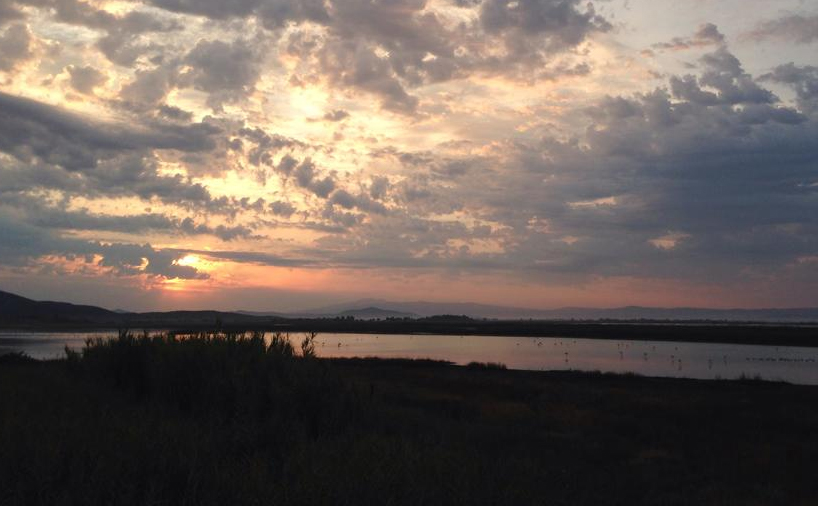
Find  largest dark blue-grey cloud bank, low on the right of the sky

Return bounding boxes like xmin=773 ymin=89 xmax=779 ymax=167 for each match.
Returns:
xmin=326 ymin=46 xmax=818 ymax=280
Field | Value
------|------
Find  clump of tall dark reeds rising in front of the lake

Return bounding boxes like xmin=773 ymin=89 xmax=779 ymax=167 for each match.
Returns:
xmin=66 ymin=332 xmax=360 ymax=437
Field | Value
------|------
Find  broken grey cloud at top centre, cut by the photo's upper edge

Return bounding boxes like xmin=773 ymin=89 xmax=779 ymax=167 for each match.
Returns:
xmin=280 ymin=0 xmax=611 ymax=115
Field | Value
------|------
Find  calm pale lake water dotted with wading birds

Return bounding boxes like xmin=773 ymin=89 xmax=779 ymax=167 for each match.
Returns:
xmin=0 ymin=331 xmax=818 ymax=385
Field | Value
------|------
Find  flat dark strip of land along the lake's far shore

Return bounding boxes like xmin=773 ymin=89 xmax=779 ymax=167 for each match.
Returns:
xmin=0 ymin=318 xmax=818 ymax=348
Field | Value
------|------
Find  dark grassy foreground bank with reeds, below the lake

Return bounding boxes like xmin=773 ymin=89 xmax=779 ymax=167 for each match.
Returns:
xmin=0 ymin=334 xmax=818 ymax=505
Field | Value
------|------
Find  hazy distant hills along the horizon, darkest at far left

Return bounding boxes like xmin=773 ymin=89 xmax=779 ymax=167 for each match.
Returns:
xmin=0 ymin=291 xmax=818 ymax=328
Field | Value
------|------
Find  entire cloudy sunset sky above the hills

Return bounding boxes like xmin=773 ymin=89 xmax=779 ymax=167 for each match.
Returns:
xmin=0 ymin=0 xmax=818 ymax=311
